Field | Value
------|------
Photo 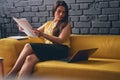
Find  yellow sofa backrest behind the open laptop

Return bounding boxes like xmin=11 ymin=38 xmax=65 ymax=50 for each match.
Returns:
xmin=70 ymin=35 xmax=120 ymax=59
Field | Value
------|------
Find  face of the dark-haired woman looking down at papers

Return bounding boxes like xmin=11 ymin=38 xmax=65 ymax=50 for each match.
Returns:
xmin=54 ymin=6 xmax=65 ymax=21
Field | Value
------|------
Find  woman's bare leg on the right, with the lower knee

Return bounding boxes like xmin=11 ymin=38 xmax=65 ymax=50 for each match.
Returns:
xmin=18 ymin=54 xmax=39 ymax=78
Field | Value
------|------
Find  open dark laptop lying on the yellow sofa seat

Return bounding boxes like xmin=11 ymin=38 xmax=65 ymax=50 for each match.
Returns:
xmin=63 ymin=48 xmax=98 ymax=63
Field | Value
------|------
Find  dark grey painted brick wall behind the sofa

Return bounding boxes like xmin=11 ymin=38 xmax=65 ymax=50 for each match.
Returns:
xmin=0 ymin=0 xmax=120 ymax=38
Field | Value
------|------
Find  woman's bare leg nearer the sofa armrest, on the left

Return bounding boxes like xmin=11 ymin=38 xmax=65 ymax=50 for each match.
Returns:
xmin=7 ymin=43 xmax=33 ymax=77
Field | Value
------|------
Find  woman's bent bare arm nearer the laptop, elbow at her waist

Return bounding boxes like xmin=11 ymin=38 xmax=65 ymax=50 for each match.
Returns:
xmin=40 ymin=23 xmax=71 ymax=44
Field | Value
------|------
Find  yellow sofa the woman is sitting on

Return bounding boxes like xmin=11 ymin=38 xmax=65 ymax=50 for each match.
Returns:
xmin=0 ymin=35 xmax=120 ymax=80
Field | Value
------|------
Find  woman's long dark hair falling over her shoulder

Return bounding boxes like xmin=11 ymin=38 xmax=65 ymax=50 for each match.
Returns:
xmin=52 ymin=0 xmax=68 ymax=36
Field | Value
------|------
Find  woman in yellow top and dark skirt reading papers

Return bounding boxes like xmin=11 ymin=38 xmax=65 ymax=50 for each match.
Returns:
xmin=8 ymin=1 xmax=71 ymax=77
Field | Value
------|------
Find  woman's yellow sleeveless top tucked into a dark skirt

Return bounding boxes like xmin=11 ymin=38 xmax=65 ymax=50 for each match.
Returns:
xmin=44 ymin=21 xmax=70 ymax=47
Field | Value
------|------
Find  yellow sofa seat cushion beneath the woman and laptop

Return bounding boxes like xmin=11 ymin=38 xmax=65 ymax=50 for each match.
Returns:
xmin=34 ymin=58 xmax=120 ymax=80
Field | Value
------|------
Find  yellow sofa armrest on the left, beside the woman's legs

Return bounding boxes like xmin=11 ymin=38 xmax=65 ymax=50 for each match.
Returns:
xmin=0 ymin=38 xmax=44 ymax=74
